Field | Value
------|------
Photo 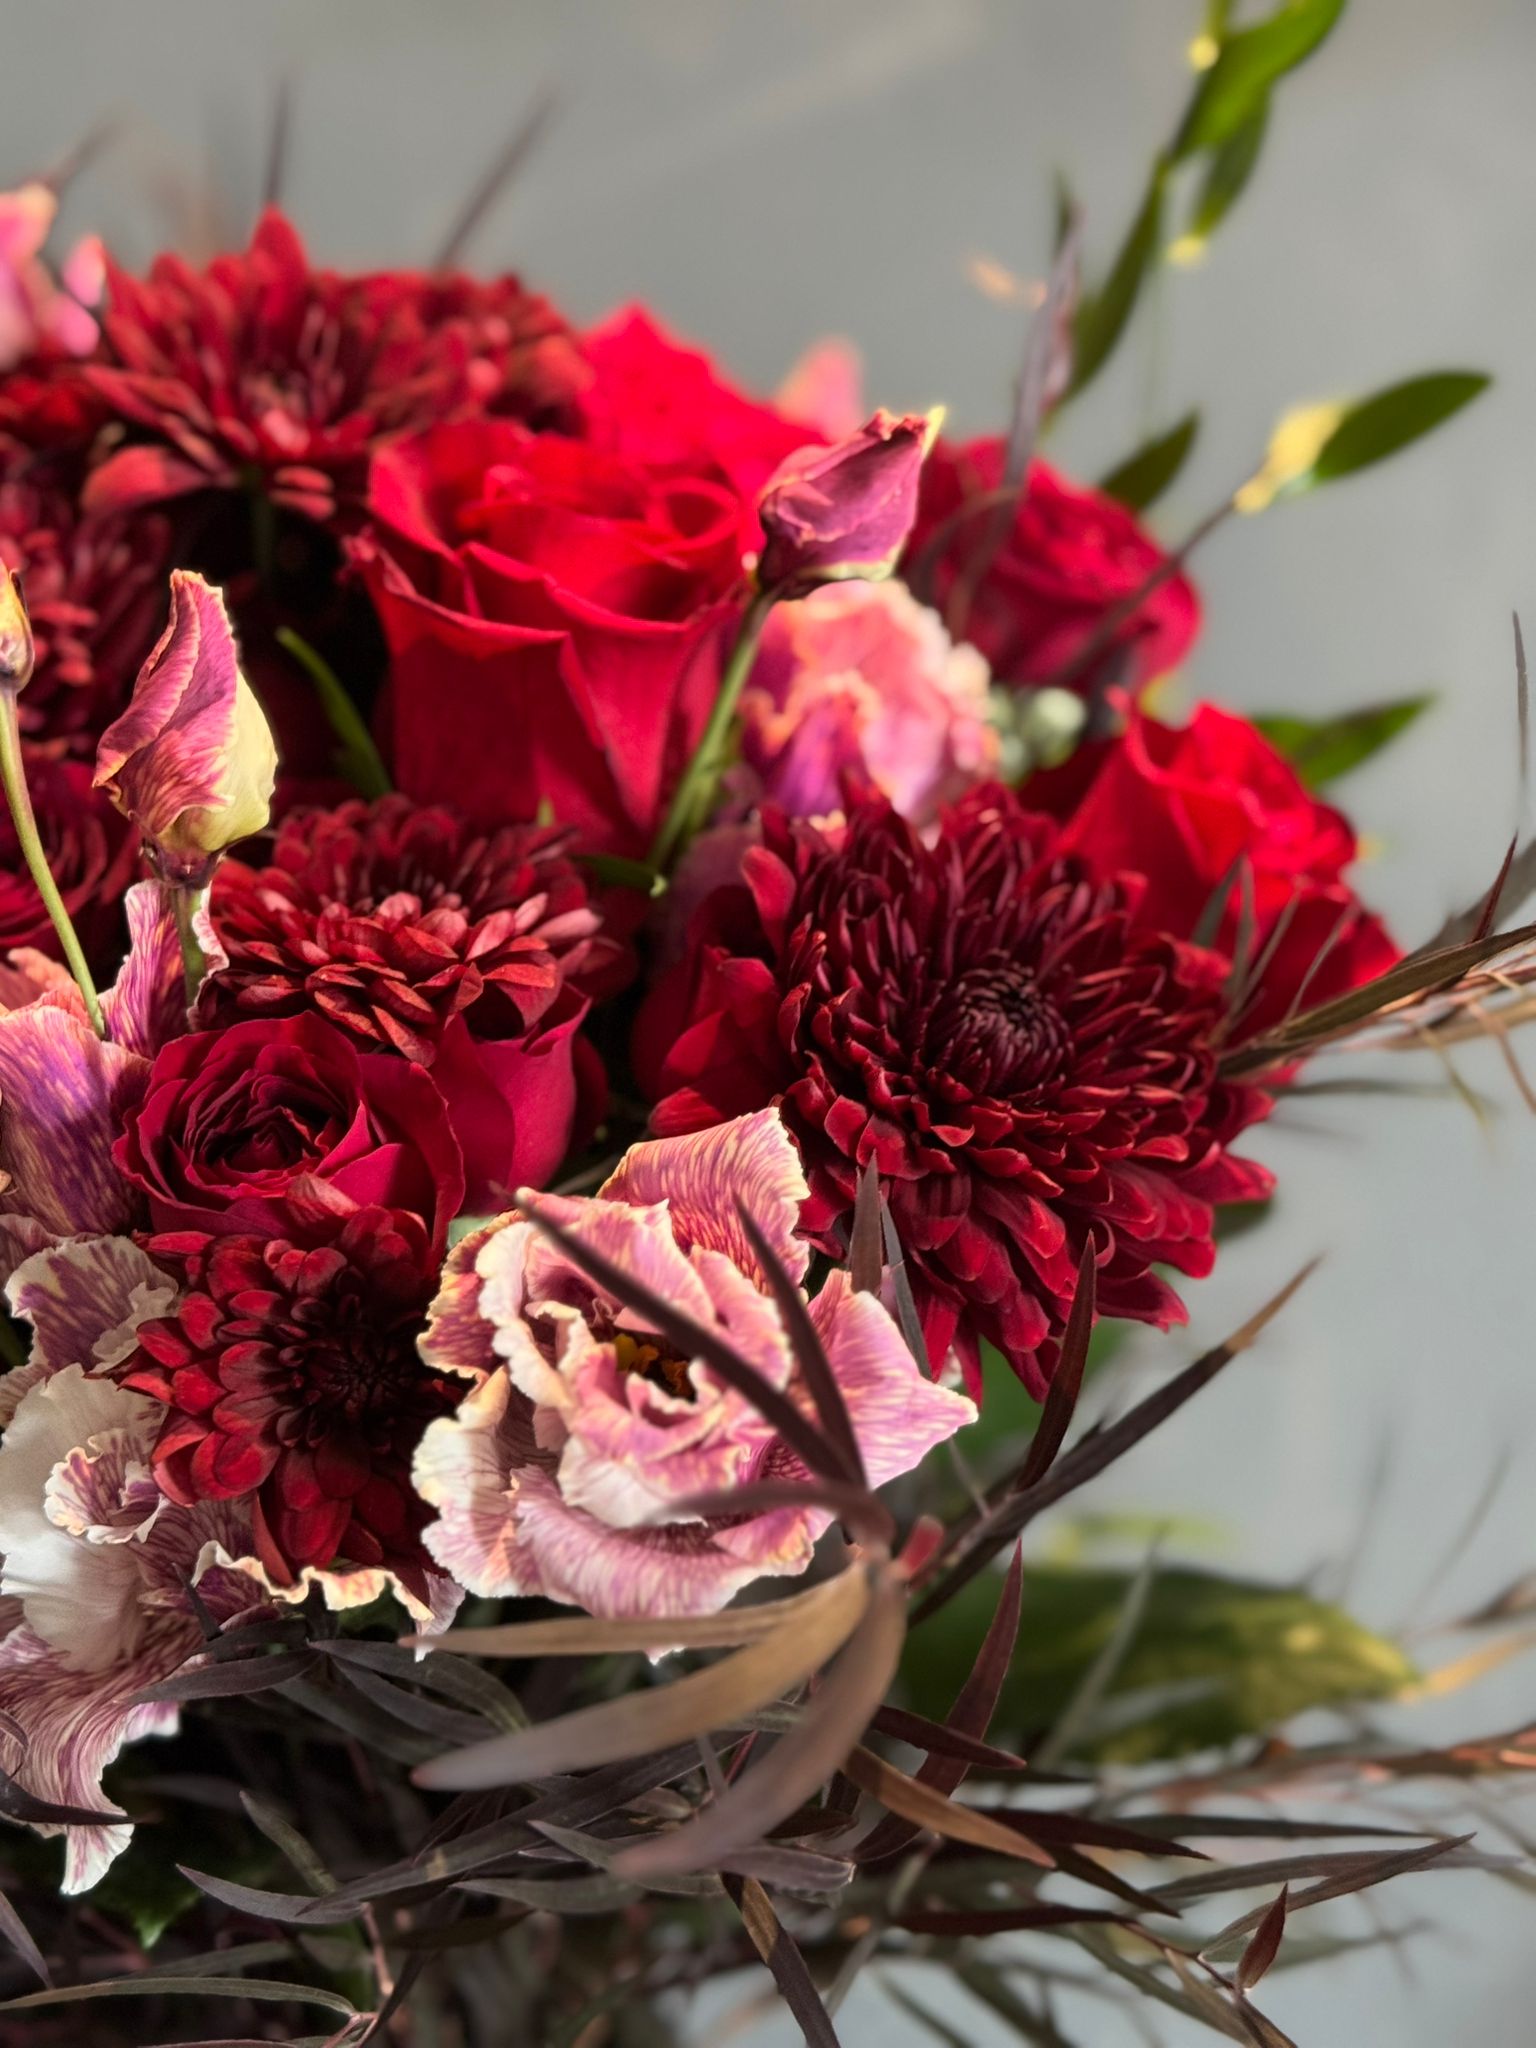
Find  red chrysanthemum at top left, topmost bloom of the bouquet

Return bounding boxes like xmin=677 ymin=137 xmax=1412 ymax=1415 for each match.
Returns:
xmin=70 ymin=209 xmax=584 ymax=520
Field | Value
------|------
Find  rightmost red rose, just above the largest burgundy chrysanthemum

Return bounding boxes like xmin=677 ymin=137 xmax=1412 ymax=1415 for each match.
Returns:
xmin=1028 ymin=705 xmax=1399 ymax=1036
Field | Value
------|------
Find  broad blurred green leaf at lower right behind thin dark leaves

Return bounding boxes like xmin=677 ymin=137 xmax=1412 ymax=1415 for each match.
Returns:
xmin=901 ymin=1565 xmax=1417 ymax=1763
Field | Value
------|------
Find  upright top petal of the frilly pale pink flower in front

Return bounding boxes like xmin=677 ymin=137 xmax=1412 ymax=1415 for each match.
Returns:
xmin=598 ymin=1110 xmax=811 ymax=1282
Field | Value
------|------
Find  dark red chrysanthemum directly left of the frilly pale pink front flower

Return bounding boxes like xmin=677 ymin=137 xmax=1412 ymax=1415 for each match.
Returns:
xmin=119 ymin=1208 xmax=463 ymax=1591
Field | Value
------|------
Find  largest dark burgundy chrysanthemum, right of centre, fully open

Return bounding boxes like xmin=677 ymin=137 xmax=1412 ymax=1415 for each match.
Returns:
xmin=653 ymin=788 xmax=1270 ymax=1395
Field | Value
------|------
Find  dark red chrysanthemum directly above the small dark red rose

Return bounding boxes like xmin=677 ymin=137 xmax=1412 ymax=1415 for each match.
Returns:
xmin=205 ymin=797 xmax=602 ymax=1063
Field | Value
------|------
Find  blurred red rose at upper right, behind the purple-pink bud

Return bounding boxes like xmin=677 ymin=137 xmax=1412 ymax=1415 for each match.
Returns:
xmin=907 ymin=438 xmax=1200 ymax=692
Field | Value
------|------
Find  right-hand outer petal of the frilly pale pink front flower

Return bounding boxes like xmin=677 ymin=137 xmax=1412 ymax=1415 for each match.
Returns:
xmin=811 ymin=1272 xmax=977 ymax=1487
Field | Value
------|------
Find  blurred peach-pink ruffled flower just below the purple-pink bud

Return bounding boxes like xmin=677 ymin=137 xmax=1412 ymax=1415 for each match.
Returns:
xmin=739 ymin=584 xmax=997 ymax=829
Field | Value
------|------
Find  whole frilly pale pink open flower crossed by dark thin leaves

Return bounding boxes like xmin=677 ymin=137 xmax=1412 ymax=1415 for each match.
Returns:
xmin=414 ymin=1110 xmax=975 ymax=1616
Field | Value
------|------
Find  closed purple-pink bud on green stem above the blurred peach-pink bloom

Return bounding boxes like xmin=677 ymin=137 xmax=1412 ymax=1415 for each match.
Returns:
xmin=758 ymin=399 xmax=942 ymax=596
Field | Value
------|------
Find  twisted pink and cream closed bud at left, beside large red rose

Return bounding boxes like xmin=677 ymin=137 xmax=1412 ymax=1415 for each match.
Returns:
xmin=96 ymin=569 xmax=276 ymax=887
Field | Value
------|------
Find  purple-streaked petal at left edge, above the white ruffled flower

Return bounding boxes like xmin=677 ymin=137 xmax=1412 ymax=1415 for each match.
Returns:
xmin=0 ymin=997 xmax=150 ymax=1237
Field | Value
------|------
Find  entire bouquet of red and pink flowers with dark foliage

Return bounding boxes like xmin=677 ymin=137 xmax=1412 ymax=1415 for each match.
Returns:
xmin=0 ymin=0 xmax=1536 ymax=2048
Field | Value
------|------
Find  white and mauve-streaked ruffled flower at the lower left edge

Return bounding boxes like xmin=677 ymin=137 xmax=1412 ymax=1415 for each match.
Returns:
xmin=0 ymin=1237 xmax=264 ymax=1892
